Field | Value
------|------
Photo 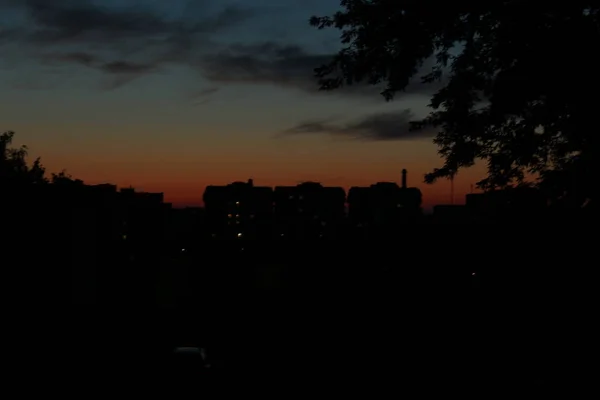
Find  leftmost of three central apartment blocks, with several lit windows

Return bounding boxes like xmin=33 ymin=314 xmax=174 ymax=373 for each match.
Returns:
xmin=203 ymin=179 xmax=273 ymax=239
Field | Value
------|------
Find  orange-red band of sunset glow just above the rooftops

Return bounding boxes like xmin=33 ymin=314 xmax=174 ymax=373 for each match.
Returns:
xmin=43 ymin=143 xmax=484 ymax=209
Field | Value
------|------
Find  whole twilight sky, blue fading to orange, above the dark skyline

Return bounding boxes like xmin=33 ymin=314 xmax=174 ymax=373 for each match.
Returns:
xmin=0 ymin=0 xmax=482 ymax=207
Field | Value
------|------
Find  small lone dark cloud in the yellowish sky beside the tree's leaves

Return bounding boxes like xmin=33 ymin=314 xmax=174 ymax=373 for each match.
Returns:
xmin=283 ymin=109 xmax=435 ymax=140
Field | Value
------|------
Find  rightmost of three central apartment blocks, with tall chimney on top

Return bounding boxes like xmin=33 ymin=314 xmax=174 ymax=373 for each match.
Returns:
xmin=348 ymin=170 xmax=422 ymax=235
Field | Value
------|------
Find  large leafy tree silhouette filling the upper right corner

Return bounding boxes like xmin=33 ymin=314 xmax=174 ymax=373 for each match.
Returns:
xmin=310 ymin=0 xmax=600 ymax=204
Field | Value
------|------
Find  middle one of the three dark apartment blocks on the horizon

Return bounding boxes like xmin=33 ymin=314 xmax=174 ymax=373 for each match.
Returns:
xmin=274 ymin=182 xmax=346 ymax=239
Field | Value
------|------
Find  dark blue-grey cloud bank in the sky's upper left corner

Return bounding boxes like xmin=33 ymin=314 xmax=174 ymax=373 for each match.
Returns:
xmin=0 ymin=0 xmax=254 ymax=86
